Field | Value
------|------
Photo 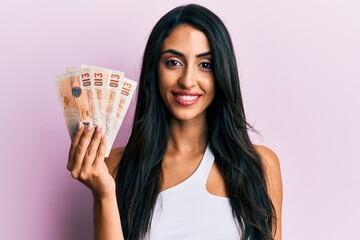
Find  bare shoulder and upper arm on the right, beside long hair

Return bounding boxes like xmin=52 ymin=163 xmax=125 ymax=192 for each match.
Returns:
xmin=255 ymin=146 xmax=283 ymax=240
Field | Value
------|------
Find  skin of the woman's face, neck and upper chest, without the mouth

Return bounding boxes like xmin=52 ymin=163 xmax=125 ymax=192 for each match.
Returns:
xmin=158 ymin=25 xmax=215 ymax=190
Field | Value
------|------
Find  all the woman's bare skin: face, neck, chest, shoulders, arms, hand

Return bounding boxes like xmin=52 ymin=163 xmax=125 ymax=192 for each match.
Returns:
xmin=67 ymin=25 xmax=282 ymax=240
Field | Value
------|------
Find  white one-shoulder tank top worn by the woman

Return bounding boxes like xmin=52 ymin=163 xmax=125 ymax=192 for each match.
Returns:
xmin=146 ymin=146 xmax=241 ymax=240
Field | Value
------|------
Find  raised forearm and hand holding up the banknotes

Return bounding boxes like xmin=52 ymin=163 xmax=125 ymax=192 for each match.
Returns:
xmin=67 ymin=123 xmax=124 ymax=240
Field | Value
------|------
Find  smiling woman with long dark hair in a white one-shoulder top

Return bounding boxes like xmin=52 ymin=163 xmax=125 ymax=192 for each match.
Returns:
xmin=67 ymin=4 xmax=282 ymax=240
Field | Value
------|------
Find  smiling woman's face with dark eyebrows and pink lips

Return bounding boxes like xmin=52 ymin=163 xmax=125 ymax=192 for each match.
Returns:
xmin=158 ymin=25 xmax=215 ymax=121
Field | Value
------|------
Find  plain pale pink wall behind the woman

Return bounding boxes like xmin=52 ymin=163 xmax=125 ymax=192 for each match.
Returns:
xmin=0 ymin=0 xmax=360 ymax=240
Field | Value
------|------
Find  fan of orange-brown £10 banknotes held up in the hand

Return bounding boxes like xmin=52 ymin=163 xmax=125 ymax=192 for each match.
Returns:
xmin=55 ymin=65 xmax=137 ymax=156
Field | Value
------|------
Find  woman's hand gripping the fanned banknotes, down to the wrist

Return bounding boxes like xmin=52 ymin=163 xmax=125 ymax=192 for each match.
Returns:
xmin=67 ymin=122 xmax=115 ymax=198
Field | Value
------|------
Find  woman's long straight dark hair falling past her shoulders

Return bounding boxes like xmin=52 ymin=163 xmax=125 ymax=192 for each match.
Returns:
xmin=116 ymin=4 xmax=276 ymax=240
